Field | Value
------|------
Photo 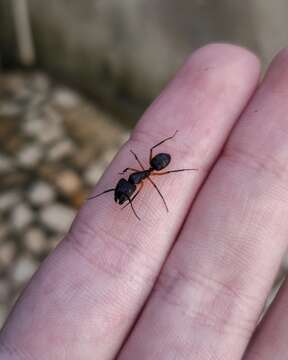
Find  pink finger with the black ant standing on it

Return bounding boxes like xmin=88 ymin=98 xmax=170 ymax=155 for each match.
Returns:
xmin=2 ymin=45 xmax=259 ymax=360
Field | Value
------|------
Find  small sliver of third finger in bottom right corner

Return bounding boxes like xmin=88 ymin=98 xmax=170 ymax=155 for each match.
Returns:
xmin=244 ymin=280 xmax=288 ymax=360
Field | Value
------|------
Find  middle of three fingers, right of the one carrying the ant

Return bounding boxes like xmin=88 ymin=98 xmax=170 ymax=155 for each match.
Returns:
xmin=119 ymin=51 xmax=288 ymax=360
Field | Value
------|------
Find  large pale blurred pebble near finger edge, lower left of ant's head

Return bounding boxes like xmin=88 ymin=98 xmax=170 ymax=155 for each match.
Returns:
xmin=40 ymin=203 xmax=76 ymax=233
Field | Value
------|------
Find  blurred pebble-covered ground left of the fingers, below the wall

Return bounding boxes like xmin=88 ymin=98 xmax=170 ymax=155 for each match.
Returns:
xmin=0 ymin=72 xmax=128 ymax=328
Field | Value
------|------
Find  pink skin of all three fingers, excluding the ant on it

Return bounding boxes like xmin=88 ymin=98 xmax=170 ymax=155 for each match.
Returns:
xmin=0 ymin=44 xmax=288 ymax=360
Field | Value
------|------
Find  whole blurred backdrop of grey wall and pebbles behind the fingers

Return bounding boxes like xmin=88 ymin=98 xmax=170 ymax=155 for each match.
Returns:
xmin=0 ymin=0 xmax=288 ymax=327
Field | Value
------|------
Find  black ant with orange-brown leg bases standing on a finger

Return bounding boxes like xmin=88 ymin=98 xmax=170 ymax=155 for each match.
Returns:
xmin=88 ymin=130 xmax=198 ymax=220
